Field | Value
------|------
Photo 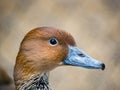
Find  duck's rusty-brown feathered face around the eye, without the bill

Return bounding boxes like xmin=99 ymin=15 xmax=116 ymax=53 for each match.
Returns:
xmin=18 ymin=27 xmax=75 ymax=71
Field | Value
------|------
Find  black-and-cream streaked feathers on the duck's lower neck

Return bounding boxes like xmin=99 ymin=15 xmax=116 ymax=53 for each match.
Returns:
xmin=17 ymin=73 xmax=51 ymax=90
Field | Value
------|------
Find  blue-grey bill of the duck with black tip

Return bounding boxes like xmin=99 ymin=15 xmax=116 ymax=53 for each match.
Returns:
xmin=63 ymin=46 xmax=105 ymax=70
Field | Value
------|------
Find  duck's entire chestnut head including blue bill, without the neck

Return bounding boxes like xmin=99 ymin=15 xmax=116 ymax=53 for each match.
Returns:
xmin=16 ymin=27 xmax=105 ymax=79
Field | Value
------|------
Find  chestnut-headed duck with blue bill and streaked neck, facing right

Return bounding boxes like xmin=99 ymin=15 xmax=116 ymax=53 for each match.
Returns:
xmin=14 ymin=27 xmax=105 ymax=90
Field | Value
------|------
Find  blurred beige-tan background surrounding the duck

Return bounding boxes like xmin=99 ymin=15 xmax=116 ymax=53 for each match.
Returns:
xmin=0 ymin=0 xmax=120 ymax=90
